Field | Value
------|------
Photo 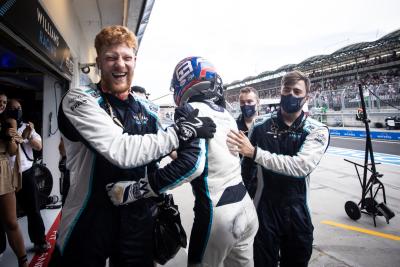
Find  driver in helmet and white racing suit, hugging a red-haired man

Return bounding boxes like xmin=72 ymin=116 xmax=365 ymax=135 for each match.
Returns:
xmin=108 ymin=57 xmax=258 ymax=267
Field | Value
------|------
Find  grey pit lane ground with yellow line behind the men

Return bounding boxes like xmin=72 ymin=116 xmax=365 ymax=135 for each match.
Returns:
xmin=164 ymin=144 xmax=400 ymax=267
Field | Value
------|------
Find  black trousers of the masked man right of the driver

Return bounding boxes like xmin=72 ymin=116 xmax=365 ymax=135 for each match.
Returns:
xmin=254 ymin=198 xmax=314 ymax=267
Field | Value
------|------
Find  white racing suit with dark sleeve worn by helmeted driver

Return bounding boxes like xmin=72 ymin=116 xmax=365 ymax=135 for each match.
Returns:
xmin=149 ymin=102 xmax=258 ymax=267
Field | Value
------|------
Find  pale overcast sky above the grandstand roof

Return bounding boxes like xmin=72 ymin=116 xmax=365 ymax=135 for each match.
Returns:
xmin=133 ymin=0 xmax=400 ymax=103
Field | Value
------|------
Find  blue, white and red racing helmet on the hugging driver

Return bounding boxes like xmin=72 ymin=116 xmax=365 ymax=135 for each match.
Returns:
xmin=171 ymin=57 xmax=224 ymax=106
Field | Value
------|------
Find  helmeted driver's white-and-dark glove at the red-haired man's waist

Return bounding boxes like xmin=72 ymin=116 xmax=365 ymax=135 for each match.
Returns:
xmin=106 ymin=178 xmax=158 ymax=206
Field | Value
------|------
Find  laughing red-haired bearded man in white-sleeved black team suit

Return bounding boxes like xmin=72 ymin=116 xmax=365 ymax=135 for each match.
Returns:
xmin=51 ymin=26 xmax=215 ymax=267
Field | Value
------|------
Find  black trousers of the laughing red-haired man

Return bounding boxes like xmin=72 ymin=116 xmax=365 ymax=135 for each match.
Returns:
xmin=49 ymin=199 xmax=154 ymax=267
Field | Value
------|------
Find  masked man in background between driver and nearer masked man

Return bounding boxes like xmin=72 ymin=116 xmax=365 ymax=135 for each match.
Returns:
xmin=236 ymin=87 xmax=260 ymax=136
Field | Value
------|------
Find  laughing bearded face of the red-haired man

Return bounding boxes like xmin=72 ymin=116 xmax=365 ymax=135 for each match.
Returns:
xmin=96 ymin=43 xmax=136 ymax=94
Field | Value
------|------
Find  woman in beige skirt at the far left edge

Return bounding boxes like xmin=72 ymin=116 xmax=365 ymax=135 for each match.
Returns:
xmin=0 ymin=93 xmax=28 ymax=267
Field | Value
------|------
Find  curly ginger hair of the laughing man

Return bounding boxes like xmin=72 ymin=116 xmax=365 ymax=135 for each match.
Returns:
xmin=94 ymin=25 xmax=137 ymax=55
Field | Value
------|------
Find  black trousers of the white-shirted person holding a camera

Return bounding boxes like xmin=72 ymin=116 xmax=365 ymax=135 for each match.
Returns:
xmin=16 ymin=169 xmax=46 ymax=244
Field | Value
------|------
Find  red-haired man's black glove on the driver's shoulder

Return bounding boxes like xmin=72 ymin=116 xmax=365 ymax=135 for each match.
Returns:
xmin=174 ymin=107 xmax=217 ymax=141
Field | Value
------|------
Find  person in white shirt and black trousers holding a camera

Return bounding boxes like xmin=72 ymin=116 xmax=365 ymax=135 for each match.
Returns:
xmin=7 ymin=99 xmax=50 ymax=253
